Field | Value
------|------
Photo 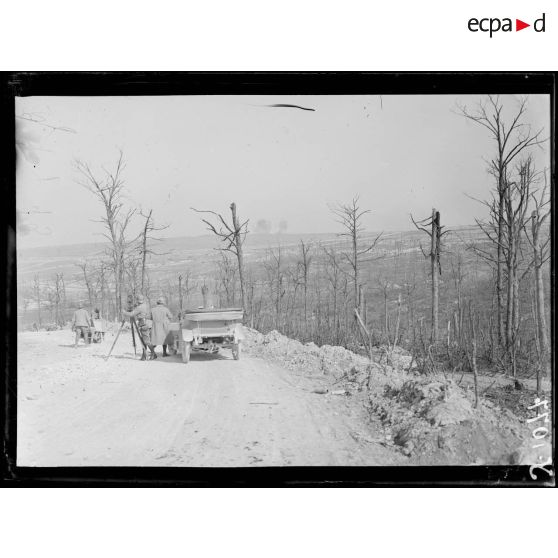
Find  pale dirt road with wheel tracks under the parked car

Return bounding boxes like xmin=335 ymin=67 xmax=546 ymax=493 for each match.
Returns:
xmin=17 ymin=330 xmax=405 ymax=467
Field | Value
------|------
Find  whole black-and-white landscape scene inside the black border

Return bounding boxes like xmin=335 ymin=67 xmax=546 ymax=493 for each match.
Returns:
xmin=7 ymin=74 xmax=553 ymax=480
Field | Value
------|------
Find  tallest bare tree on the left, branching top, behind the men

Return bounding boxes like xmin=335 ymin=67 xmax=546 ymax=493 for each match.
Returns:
xmin=75 ymin=151 xmax=136 ymax=318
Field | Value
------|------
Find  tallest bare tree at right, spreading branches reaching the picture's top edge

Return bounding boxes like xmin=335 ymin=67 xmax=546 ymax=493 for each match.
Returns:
xmin=459 ymin=96 xmax=544 ymax=345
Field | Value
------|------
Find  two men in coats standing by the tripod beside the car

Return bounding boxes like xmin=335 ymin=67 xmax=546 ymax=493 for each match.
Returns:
xmin=122 ymin=295 xmax=172 ymax=360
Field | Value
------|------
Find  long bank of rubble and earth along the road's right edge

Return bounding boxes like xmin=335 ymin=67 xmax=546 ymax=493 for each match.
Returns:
xmin=246 ymin=330 xmax=540 ymax=465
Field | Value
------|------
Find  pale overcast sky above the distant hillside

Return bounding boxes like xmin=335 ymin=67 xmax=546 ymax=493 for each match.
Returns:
xmin=16 ymin=95 xmax=550 ymax=248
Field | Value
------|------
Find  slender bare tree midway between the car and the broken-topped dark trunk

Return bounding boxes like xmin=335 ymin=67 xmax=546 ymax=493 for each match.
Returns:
xmin=330 ymin=196 xmax=383 ymax=316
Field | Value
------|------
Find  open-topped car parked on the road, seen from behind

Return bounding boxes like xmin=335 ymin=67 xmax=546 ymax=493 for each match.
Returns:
xmin=168 ymin=308 xmax=244 ymax=362
